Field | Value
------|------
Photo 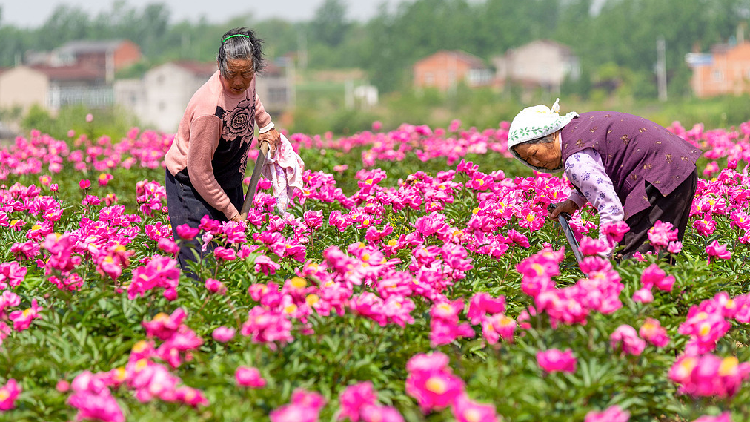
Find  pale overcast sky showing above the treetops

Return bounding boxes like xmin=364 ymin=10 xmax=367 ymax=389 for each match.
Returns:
xmin=0 ymin=0 xmax=408 ymax=28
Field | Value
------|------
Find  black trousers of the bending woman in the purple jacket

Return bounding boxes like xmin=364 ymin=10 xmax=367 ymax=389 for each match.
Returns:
xmin=618 ymin=169 xmax=698 ymax=258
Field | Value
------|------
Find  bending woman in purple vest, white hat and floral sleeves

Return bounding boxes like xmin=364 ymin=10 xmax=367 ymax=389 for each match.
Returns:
xmin=508 ymin=99 xmax=701 ymax=258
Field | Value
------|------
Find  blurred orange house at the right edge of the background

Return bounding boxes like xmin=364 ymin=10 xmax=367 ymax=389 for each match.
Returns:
xmin=686 ymin=38 xmax=750 ymax=98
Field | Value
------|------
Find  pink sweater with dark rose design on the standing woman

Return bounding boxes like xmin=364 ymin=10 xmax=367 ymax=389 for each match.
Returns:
xmin=165 ymin=70 xmax=271 ymax=220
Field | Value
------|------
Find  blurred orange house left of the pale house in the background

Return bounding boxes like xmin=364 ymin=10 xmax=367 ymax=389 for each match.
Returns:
xmin=413 ymin=50 xmax=492 ymax=92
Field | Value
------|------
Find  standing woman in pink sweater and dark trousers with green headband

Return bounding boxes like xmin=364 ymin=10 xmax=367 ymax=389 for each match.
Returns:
xmin=165 ymin=27 xmax=279 ymax=271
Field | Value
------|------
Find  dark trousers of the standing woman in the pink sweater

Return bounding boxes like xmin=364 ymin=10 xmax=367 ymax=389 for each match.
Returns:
xmin=165 ymin=170 xmax=244 ymax=278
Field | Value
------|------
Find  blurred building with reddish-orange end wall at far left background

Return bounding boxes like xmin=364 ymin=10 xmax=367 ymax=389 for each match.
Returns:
xmin=25 ymin=40 xmax=142 ymax=83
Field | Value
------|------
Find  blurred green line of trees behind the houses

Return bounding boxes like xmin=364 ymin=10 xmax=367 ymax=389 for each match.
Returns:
xmin=0 ymin=0 xmax=750 ymax=98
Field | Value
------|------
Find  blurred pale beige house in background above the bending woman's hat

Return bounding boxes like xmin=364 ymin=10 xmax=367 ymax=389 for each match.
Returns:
xmin=492 ymin=40 xmax=581 ymax=95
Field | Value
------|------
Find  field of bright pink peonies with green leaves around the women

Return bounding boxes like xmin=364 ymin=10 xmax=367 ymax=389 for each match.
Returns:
xmin=0 ymin=116 xmax=750 ymax=422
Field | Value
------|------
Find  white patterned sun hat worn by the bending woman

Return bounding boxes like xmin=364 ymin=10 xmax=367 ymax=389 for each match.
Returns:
xmin=508 ymin=98 xmax=578 ymax=173
